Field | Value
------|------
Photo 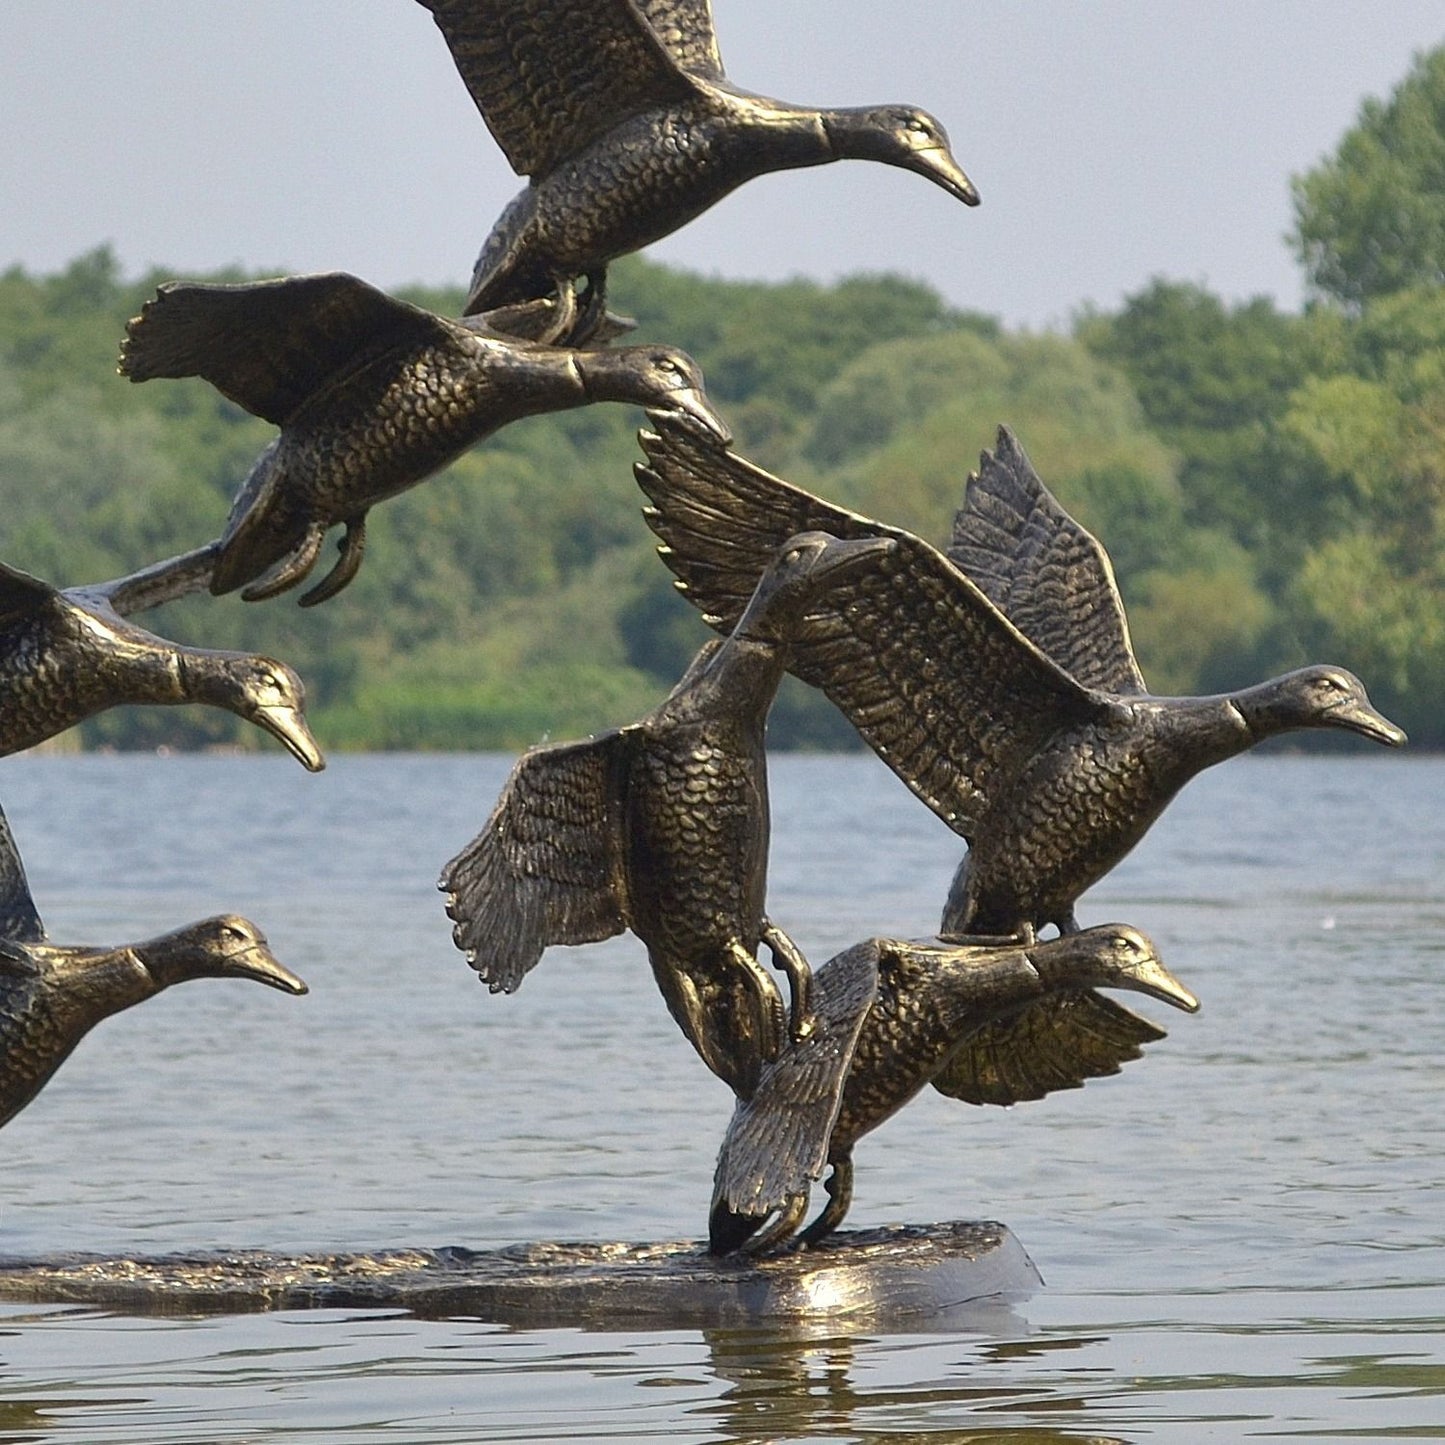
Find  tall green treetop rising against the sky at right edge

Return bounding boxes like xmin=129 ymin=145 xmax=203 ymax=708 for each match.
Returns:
xmin=1292 ymin=46 xmax=1445 ymax=308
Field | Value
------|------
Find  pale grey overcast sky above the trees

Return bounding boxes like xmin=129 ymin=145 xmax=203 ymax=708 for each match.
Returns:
xmin=0 ymin=0 xmax=1445 ymax=328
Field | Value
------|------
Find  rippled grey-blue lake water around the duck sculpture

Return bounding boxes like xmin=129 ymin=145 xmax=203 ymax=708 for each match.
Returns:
xmin=0 ymin=754 xmax=1445 ymax=1445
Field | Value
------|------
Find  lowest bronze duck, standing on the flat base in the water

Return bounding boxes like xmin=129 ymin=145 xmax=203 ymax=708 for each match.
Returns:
xmin=709 ymin=923 xmax=1199 ymax=1254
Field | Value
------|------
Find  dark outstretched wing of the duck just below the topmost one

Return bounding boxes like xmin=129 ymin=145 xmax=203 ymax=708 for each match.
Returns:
xmin=120 ymin=272 xmax=451 ymax=426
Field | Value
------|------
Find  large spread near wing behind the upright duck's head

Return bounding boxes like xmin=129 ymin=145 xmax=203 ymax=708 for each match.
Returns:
xmin=636 ymin=412 xmax=1103 ymax=838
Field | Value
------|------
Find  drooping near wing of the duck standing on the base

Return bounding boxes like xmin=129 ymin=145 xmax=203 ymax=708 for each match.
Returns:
xmin=712 ymin=941 xmax=879 ymax=1218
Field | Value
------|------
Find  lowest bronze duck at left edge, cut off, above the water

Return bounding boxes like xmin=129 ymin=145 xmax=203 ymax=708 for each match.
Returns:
xmin=0 ymin=812 xmax=306 ymax=1124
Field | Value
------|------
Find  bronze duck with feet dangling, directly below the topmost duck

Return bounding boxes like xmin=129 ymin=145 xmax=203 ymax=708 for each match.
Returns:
xmin=120 ymin=272 xmax=727 ymax=607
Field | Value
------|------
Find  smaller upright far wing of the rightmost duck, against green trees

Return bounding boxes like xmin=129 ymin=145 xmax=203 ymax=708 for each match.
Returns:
xmin=948 ymin=426 xmax=1144 ymax=694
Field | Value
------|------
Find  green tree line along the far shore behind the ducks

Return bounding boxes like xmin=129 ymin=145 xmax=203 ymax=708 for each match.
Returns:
xmin=0 ymin=49 xmax=1445 ymax=749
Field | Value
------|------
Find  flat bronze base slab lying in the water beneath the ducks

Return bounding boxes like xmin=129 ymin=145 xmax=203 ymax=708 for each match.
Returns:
xmin=0 ymin=1222 xmax=1039 ymax=1329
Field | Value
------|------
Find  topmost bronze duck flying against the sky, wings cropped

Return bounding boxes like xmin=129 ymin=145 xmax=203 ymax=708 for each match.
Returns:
xmin=420 ymin=0 xmax=978 ymax=338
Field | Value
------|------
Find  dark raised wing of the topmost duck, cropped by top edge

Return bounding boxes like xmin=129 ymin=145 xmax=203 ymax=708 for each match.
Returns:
xmin=419 ymin=0 xmax=695 ymax=181
